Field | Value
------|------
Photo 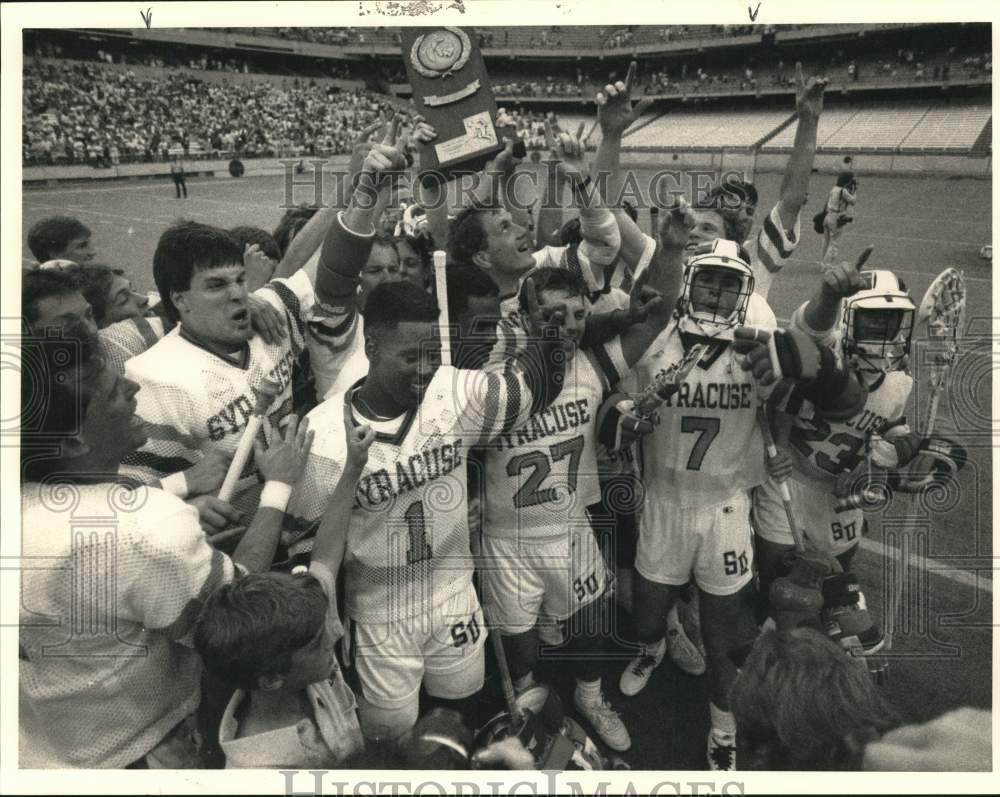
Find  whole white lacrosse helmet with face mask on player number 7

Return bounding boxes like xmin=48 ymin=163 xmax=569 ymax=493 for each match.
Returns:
xmin=678 ymin=239 xmax=754 ymax=340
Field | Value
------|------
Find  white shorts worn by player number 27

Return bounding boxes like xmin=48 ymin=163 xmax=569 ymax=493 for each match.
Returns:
xmin=480 ymin=523 xmax=607 ymax=634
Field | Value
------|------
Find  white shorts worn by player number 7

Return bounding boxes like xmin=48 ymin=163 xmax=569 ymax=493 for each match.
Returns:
xmin=635 ymin=493 xmax=753 ymax=595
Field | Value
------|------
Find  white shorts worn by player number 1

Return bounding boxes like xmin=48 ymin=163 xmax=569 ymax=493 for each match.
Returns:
xmin=345 ymin=584 xmax=486 ymax=711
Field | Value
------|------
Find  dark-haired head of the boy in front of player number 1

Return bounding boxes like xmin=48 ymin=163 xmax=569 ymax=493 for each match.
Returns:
xmin=194 ymin=572 xmax=330 ymax=689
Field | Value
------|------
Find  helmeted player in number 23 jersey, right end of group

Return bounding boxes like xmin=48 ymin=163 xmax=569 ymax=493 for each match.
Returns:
xmin=754 ymin=250 xmax=920 ymax=654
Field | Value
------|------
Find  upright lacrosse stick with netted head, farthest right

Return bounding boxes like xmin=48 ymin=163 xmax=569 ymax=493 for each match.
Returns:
xmin=885 ymin=268 xmax=965 ymax=664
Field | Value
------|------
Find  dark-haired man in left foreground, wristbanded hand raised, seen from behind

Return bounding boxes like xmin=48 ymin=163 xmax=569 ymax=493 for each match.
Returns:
xmin=18 ymin=328 xmax=309 ymax=769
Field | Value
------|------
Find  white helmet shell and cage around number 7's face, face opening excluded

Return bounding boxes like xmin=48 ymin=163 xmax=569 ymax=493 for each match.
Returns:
xmin=677 ymin=238 xmax=754 ymax=340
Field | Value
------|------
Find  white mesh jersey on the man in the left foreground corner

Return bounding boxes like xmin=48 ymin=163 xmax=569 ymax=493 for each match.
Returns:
xmin=19 ymin=484 xmax=233 ymax=768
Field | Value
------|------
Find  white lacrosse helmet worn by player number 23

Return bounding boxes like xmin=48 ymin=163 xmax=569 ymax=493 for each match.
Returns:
xmin=840 ymin=271 xmax=916 ymax=378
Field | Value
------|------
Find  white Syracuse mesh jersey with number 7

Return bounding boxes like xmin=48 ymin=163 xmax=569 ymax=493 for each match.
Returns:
xmin=634 ymin=296 xmax=776 ymax=510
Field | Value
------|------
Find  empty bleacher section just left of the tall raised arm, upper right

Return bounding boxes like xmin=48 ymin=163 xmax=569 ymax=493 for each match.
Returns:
xmin=622 ymin=111 xmax=796 ymax=149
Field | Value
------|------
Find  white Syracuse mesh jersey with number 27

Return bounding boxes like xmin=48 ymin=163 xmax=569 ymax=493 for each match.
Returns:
xmin=483 ymin=340 xmax=627 ymax=540
